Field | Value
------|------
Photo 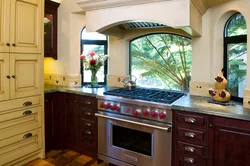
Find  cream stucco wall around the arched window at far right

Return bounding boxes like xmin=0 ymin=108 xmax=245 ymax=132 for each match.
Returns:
xmin=190 ymin=0 xmax=250 ymax=96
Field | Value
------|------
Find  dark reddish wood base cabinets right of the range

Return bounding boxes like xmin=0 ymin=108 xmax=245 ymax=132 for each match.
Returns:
xmin=173 ymin=111 xmax=250 ymax=166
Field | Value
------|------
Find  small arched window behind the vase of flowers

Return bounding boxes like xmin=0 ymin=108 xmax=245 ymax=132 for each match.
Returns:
xmin=81 ymin=27 xmax=108 ymax=85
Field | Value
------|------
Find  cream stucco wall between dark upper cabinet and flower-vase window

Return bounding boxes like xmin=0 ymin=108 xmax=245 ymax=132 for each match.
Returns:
xmin=44 ymin=0 xmax=85 ymax=74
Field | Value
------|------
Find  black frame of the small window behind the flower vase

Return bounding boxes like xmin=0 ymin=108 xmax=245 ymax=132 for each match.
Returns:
xmin=80 ymin=27 xmax=108 ymax=86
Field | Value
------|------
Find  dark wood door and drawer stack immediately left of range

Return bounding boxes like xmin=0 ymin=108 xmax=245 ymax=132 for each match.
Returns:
xmin=63 ymin=93 xmax=97 ymax=157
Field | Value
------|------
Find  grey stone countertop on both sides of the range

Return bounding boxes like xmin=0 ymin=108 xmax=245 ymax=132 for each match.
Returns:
xmin=44 ymin=85 xmax=250 ymax=121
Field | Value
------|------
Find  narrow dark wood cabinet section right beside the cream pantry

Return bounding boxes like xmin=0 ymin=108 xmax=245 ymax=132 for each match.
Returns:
xmin=44 ymin=93 xmax=63 ymax=152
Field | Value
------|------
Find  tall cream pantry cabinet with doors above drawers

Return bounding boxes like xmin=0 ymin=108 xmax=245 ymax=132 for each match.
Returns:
xmin=0 ymin=0 xmax=44 ymax=165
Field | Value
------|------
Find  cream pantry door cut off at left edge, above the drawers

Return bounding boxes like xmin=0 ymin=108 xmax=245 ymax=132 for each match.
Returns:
xmin=0 ymin=53 xmax=10 ymax=101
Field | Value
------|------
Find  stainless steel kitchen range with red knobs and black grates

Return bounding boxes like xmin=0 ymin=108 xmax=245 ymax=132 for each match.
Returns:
xmin=95 ymin=88 xmax=184 ymax=166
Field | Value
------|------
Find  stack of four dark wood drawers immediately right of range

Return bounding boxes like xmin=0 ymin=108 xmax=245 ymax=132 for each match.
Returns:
xmin=173 ymin=111 xmax=208 ymax=166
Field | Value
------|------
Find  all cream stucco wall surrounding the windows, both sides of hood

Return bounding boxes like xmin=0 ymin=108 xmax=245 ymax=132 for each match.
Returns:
xmin=45 ymin=0 xmax=250 ymax=100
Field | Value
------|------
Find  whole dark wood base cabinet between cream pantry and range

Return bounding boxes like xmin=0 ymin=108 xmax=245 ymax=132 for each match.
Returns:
xmin=45 ymin=93 xmax=97 ymax=157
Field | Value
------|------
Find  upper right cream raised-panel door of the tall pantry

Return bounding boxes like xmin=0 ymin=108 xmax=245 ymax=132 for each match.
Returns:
xmin=10 ymin=0 xmax=43 ymax=53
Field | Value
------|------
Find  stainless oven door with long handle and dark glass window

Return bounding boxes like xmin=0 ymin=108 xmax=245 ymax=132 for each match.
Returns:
xmin=96 ymin=112 xmax=172 ymax=166
